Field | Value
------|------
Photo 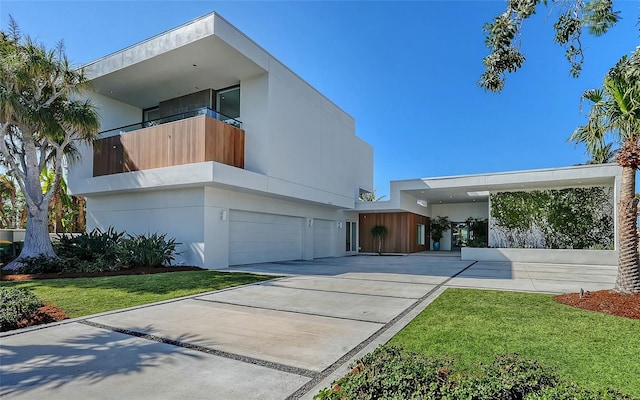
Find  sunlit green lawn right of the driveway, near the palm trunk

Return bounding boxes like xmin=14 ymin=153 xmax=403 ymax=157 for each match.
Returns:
xmin=390 ymin=289 xmax=640 ymax=396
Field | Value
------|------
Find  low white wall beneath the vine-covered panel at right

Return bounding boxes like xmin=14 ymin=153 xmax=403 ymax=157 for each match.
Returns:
xmin=460 ymin=247 xmax=618 ymax=265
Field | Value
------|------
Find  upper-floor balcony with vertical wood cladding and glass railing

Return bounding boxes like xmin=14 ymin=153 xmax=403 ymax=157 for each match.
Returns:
xmin=93 ymin=108 xmax=244 ymax=176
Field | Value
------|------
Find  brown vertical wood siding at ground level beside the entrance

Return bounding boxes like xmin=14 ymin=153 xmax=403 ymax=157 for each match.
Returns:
xmin=359 ymin=212 xmax=429 ymax=253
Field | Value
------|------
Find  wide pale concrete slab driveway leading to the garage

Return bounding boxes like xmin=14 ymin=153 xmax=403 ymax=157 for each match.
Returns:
xmin=0 ymin=253 xmax=616 ymax=400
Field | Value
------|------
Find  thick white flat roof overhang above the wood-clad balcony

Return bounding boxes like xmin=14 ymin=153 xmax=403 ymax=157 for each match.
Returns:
xmin=83 ymin=14 xmax=270 ymax=108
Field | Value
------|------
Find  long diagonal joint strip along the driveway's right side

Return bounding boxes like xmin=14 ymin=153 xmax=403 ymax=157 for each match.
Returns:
xmin=286 ymin=261 xmax=478 ymax=400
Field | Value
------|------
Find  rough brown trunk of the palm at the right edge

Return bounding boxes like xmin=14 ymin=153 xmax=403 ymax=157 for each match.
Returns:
xmin=614 ymin=166 xmax=640 ymax=293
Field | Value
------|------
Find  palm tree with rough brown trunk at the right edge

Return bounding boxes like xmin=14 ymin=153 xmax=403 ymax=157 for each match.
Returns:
xmin=570 ymin=47 xmax=640 ymax=293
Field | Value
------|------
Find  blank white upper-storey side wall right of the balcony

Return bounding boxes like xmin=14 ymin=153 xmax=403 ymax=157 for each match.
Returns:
xmin=262 ymin=60 xmax=373 ymax=197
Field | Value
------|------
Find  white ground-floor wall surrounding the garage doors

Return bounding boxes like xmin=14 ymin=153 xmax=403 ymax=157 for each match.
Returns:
xmin=87 ymin=187 xmax=357 ymax=268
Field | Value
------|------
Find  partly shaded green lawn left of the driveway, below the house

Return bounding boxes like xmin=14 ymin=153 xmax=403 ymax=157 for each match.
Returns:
xmin=0 ymin=271 xmax=273 ymax=318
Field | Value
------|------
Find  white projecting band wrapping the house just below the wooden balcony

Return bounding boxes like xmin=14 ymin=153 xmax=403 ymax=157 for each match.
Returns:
xmin=70 ymin=161 xmax=354 ymax=209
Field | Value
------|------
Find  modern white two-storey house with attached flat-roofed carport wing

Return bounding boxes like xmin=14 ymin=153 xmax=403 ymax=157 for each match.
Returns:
xmin=68 ymin=13 xmax=621 ymax=268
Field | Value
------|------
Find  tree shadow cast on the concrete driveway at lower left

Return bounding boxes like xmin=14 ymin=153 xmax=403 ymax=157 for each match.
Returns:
xmin=0 ymin=324 xmax=205 ymax=397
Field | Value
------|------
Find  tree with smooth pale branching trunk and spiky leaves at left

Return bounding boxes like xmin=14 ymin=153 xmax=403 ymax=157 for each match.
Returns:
xmin=0 ymin=19 xmax=98 ymax=269
